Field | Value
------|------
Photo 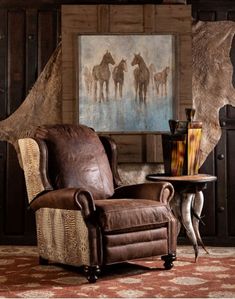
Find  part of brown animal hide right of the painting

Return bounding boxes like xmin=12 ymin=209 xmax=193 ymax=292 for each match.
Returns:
xmin=192 ymin=21 xmax=235 ymax=166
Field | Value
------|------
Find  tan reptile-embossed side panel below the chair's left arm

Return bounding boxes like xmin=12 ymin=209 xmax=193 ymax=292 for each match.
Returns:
xmin=36 ymin=208 xmax=90 ymax=266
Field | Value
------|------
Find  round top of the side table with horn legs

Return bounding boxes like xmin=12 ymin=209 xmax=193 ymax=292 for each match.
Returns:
xmin=146 ymin=173 xmax=217 ymax=184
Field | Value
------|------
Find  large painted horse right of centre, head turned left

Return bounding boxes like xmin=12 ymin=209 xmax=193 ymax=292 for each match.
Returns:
xmin=131 ymin=54 xmax=150 ymax=103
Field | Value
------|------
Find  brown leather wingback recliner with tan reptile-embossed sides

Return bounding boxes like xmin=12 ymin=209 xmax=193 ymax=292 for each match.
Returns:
xmin=19 ymin=125 xmax=177 ymax=282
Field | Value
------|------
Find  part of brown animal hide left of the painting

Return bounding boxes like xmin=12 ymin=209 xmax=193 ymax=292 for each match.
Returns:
xmin=0 ymin=45 xmax=62 ymax=162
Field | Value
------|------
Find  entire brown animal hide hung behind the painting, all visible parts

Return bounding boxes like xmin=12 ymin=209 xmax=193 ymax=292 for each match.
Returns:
xmin=0 ymin=11 xmax=235 ymax=183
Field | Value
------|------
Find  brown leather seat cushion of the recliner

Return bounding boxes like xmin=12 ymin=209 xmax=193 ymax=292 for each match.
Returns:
xmin=95 ymin=199 xmax=172 ymax=232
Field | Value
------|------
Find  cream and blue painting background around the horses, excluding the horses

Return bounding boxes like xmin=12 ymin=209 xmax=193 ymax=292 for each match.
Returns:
xmin=78 ymin=35 xmax=175 ymax=132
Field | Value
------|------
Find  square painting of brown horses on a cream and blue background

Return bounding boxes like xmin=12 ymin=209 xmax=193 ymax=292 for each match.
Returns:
xmin=76 ymin=34 xmax=176 ymax=133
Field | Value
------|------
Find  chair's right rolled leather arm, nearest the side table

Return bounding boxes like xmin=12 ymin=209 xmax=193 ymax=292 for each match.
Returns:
xmin=112 ymin=182 xmax=174 ymax=204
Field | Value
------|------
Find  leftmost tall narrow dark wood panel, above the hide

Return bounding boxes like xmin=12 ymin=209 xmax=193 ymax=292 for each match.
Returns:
xmin=8 ymin=10 xmax=25 ymax=114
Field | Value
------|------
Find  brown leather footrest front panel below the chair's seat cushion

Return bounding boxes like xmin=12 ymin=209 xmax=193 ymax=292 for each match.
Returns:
xmin=103 ymin=227 xmax=168 ymax=264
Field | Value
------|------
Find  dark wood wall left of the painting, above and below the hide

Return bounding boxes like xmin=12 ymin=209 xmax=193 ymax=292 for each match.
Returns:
xmin=0 ymin=5 xmax=60 ymax=244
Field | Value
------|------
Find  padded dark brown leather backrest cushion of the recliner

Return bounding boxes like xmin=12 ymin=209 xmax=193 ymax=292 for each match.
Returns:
xmin=35 ymin=125 xmax=114 ymax=199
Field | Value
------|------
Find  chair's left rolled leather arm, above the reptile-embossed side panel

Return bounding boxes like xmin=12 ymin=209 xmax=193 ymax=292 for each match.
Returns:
xmin=30 ymin=188 xmax=95 ymax=217
